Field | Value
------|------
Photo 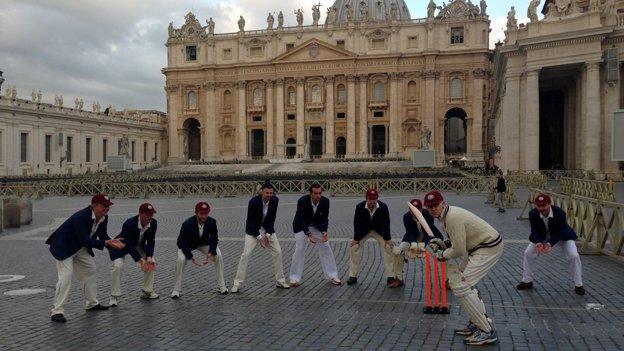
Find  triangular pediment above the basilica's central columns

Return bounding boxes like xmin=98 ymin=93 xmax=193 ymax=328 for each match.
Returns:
xmin=273 ymin=39 xmax=356 ymax=63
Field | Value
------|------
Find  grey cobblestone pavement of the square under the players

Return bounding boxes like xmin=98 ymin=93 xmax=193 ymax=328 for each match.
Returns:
xmin=0 ymin=192 xmax=624 ymax=351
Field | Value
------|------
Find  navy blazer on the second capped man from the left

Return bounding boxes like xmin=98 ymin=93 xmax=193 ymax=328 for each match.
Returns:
xmin=108 ymin=215 xmax=158 ymax=262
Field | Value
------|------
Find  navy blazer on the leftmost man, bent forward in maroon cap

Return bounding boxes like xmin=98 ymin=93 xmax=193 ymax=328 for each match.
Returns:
xmin=46 ymin=206 xmax=110 ymax=261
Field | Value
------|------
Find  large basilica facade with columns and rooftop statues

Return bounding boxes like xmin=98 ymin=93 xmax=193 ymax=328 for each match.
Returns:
xmin=162 ymin=0 xmax=490 ymax=165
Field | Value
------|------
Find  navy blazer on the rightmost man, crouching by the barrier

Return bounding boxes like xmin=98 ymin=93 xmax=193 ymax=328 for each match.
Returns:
xmin=529 ymin=206 xmax=576 ymax=246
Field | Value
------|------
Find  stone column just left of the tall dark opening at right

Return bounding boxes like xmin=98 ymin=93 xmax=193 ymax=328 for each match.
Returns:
xmin=520 ymin=70 xmax=540 ymax=171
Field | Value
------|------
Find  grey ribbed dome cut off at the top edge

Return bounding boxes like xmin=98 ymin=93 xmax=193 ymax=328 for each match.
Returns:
xmin=325 ymin=0 xmax=411 ymax=25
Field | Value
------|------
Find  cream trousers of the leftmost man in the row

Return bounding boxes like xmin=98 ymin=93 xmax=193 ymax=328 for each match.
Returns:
xmin=52 ymin=247 xmax=99 ymax=314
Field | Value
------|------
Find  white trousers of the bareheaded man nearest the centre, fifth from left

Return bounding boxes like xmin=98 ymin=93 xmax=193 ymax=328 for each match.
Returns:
xmin=290 ymin=226 xmax=338 ymax=283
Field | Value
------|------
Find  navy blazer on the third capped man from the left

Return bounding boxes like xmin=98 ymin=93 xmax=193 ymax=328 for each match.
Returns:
xmin=177 ymin=216 xmax=219 ymax=260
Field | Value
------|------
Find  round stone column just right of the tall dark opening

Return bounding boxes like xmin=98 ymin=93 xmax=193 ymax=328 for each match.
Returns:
xmin=583 ymin=62 xmax=602 ymax=170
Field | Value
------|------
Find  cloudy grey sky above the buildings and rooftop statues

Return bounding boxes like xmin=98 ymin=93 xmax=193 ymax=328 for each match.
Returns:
xmin=0 ymin=0 xmax=529 ymax=111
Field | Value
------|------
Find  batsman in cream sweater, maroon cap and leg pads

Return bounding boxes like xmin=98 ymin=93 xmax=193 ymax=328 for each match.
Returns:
xmin=424 ymin=191 xmax=503 ymax=345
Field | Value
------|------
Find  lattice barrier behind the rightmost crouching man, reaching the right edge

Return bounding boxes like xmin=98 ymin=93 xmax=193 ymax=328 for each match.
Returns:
xmin=518 ymin=188 xmax=624 ymax=256
